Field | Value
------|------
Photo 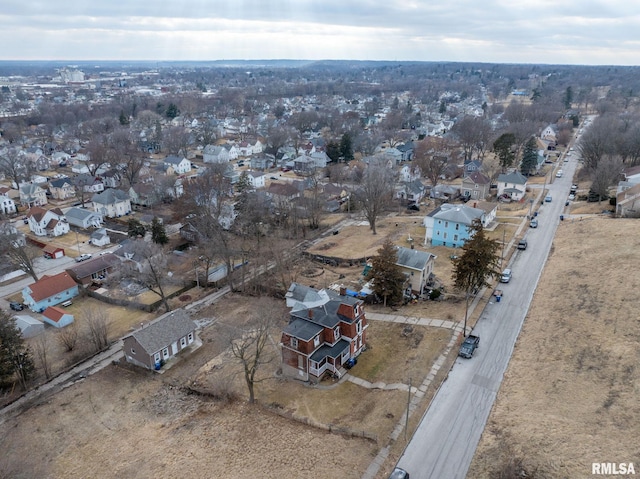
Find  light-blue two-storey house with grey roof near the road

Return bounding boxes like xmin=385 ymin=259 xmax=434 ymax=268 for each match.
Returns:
xmin=424 ymin=203 xmax=486 ymax=248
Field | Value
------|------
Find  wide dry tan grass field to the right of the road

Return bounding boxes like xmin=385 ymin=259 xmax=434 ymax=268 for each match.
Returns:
xmin=470 ymin=217 xmax=640 ymax=478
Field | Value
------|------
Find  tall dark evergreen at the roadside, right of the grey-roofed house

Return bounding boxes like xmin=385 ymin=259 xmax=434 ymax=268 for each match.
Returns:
xmin=452 ymin=219 xmax=500 ymax=336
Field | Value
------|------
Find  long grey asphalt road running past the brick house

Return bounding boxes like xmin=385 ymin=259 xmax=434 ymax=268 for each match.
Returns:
xmin=398 ymin=151 xmax=577 ymax=479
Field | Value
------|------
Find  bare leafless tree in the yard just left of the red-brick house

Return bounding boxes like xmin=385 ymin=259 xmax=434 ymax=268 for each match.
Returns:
xmin=230 ymin=299 xmax=282 ymax=404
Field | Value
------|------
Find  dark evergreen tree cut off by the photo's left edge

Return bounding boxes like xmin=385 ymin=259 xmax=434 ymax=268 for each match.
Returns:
xmin=0 ymin=310 xmax=35 ymax=389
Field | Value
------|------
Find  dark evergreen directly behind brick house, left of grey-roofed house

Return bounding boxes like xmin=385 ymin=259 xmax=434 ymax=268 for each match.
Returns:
xmin=367 ymin=239 xmax=405 ymax=306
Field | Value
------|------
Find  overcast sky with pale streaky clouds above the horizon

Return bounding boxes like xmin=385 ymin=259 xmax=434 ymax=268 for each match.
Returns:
xmin=0 ymin=0 xmax=640 ymax=65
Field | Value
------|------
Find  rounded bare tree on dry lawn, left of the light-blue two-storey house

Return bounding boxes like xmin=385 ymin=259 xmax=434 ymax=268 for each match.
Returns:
xmin=355 ymin=165 xmax=395 ymax=235
